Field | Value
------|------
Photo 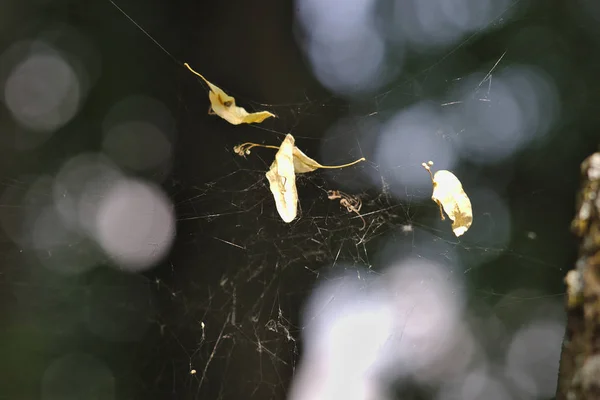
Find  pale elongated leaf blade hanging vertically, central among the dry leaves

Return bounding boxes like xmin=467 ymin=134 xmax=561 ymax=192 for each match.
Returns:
xmin=266 ymin=134 xmax=298 ymax=223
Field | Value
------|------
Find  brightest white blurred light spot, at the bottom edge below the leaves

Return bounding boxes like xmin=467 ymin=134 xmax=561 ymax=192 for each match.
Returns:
xmin=288 ymin=275 xmax=393 ymax=400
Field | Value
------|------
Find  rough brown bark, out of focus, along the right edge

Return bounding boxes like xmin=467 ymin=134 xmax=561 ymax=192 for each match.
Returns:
xmin=556 ymin=153 xmax=600 ymax=400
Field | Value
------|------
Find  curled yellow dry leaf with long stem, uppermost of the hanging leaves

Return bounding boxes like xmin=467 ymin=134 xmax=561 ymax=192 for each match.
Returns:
xmin=183 ymin=63 xmax=275 ymax=125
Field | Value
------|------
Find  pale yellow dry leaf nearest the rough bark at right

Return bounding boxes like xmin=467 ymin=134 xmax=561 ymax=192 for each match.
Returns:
xmin=421 ymin=161 xmax=473 ymax=237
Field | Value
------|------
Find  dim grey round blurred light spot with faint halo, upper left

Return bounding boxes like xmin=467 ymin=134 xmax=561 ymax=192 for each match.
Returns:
xmin=0 ymin=24 xmax=102 ymax=151
